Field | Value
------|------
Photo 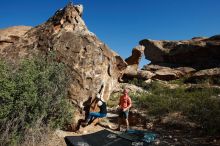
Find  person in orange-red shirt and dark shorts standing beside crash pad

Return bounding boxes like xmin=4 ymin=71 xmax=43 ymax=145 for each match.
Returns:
xmin=116 ymin=88 xmax=132 ymax=131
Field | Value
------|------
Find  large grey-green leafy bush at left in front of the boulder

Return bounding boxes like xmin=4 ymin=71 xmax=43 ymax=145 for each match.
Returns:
xmin=0 ymin=58 xmax=73 ymax=145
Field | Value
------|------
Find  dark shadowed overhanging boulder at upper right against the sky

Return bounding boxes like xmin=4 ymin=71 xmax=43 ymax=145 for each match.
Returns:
xmin=139 ymin=35 xmax=220 ymax=69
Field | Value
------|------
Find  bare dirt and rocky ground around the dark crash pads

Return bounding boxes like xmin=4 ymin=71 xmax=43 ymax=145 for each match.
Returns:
xmin=49 ymin=112 xmax=220 ymax=146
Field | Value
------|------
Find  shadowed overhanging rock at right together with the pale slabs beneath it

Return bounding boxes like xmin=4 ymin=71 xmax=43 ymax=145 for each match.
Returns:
xmin=139 ymin=35 xmax=220 ymax=80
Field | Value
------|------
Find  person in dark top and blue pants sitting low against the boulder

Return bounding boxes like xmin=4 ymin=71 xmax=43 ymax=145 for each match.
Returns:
xmin=82 ymin=94 xmax=107 ymax=126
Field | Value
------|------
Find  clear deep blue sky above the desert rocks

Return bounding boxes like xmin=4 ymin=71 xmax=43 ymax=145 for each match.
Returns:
xmin=0 ymin=0 xmax=220 ymax=66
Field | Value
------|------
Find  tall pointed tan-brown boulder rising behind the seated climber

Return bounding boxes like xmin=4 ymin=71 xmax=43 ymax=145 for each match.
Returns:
xmin=1 ymin=3 xmax=127 ymax=125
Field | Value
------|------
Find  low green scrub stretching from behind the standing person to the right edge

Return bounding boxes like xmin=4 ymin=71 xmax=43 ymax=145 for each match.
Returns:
xmin=131 ymin=82 xmax=220 ymax=134
